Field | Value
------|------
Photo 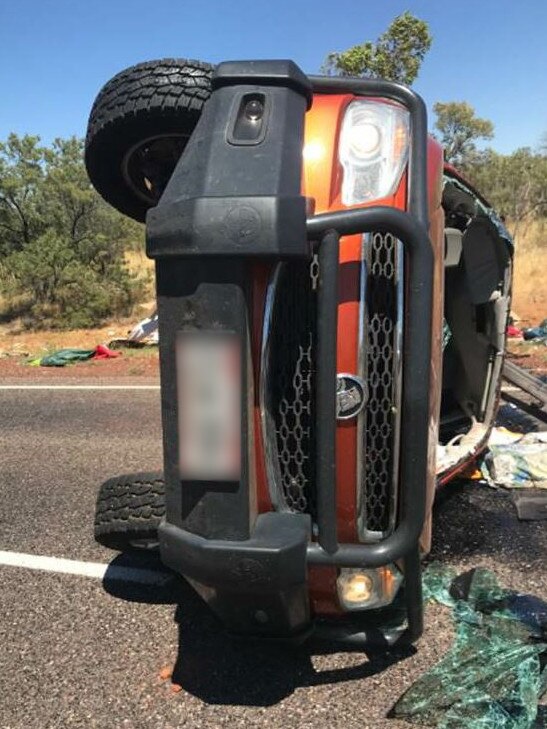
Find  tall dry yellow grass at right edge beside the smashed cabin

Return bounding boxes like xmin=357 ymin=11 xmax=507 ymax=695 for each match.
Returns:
xmin=509 ymin=219 xmax=547 ymax=326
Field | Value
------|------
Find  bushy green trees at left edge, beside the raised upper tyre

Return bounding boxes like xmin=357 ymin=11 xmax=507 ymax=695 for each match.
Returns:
xmin=0 ymin=135 xmax=144 ymax=327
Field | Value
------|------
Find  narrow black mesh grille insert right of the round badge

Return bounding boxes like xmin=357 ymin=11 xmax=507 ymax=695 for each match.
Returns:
xmin=360 ymin=233 xmax=399 ymax=532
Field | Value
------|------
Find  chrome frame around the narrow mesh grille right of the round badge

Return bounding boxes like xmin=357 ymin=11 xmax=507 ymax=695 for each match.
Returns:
xmin=356 ymin=233 xmax=404 ymax=543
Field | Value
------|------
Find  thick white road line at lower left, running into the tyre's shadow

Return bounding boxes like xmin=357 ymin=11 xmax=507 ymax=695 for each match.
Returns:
xmin=0 ymin=551 xmax=172 ymax=585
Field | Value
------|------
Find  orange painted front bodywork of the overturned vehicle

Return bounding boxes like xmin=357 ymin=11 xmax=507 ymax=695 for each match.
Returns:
xmin=246 ymin=94 xmax=448 ymax=615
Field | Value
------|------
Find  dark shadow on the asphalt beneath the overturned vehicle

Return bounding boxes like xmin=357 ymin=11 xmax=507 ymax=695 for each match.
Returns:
xmin=103 ymin=554 xmax=415 ymax=707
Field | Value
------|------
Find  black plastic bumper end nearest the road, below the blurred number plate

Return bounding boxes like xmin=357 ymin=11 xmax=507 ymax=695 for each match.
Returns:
xmin=160 ymin=513 xmax=311 ymax=638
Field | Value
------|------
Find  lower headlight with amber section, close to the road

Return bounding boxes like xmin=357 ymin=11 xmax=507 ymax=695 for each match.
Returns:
xmin=336 ymin=564 xmax=403 ymax=610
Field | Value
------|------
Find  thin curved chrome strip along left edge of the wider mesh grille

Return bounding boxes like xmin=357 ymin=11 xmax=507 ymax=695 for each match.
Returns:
xmin=259 ymin=263 xmax=288 ymax=511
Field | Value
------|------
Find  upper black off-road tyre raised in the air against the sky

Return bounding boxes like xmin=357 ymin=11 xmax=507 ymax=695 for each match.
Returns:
xmin=85 ymin=58 xmax=214 ymax=222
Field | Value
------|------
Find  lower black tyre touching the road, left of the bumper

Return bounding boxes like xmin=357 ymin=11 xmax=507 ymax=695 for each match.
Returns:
xmin=94 ymin=472 xmax=165 ymax=552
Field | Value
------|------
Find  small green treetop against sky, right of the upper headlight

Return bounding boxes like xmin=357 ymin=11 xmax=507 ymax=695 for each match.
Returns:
xmin=433 ymin=101 xmax=494 ymax=167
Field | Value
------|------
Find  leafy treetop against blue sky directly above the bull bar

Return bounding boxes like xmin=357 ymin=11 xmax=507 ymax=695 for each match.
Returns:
xmin=323 ymin=11 xmax=432 ymax=84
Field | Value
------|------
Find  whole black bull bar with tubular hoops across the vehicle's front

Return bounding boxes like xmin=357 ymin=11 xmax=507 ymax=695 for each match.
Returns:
xmin=147 ymin=62 xmax=433 ymax=639
